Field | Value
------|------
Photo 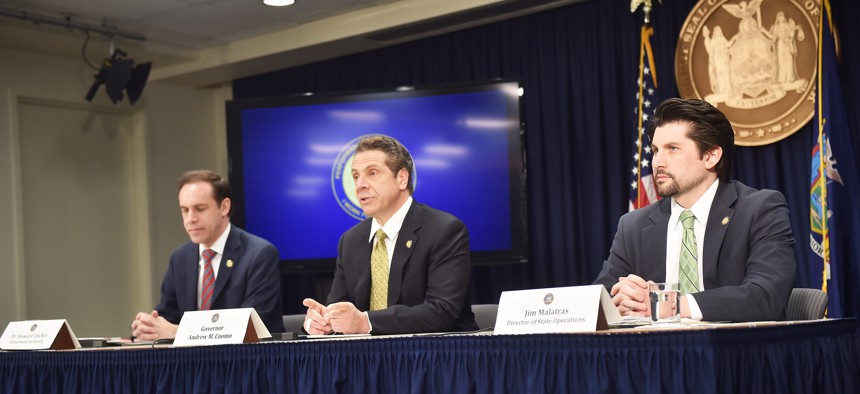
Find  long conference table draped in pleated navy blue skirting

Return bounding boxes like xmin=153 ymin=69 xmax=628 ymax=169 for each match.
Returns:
xmin=0 ymin=319 xmax=860 ymax=393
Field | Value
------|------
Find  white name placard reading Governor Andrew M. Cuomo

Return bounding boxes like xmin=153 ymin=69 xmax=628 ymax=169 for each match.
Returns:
xmin=173 ymin=308 xmax=272 ymax=346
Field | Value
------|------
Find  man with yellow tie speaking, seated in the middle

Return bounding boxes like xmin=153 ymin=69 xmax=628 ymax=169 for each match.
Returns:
xmin=304 ymin=136 xmax=478 ymax=334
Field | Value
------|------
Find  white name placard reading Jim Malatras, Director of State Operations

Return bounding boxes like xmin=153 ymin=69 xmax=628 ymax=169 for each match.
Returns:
xmin=493 ymin=285 xmax=621 ymax=334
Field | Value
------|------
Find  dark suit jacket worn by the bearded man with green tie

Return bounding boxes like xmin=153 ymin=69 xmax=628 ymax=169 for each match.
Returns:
xmin=594 ymin=181 xmax=796 ymax=321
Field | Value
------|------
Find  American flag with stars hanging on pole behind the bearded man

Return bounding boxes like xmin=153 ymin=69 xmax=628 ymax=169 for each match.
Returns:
xmin=629 ymin=26 xmax=660 ymax=211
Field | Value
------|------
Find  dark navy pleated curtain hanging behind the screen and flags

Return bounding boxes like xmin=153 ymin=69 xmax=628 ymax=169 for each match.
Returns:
xmin=233 ymin=0 xmax=860 ymax=316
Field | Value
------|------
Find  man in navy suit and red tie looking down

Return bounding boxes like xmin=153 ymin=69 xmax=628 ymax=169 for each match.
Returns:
xmin=131 ymin=171 xmax=284 ymax=340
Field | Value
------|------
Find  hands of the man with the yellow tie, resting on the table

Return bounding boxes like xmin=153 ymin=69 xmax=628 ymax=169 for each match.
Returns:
xmin=302 ymin=298 xmax=370 ymax=335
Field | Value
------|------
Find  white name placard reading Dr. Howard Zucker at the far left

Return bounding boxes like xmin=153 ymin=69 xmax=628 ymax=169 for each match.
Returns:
xmin=0 ymin=319 xmax=81 ymax=350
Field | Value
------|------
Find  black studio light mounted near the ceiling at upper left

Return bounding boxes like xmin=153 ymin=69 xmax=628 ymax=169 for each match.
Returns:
xmin=86 ymin=48 xmax=152 ymax=104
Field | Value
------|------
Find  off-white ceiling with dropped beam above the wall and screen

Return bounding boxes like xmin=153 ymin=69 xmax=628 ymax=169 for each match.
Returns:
xmin=0 ymin=0 xmax=582 ymax=86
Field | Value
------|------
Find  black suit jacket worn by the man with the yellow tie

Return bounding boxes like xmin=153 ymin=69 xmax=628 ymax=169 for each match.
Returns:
xmin=328 ymin=200 xmax=478 ymax=334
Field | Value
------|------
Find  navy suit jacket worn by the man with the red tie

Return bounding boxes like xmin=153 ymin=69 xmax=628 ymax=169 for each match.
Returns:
xmin=155 ymin=226 xmax=284 ymax=332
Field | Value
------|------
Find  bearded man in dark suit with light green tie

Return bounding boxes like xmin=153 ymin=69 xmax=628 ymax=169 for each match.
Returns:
xmin=594 ymin=99 xmax=796 ymax=321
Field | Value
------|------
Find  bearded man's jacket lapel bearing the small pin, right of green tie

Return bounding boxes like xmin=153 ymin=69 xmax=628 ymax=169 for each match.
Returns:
xmin=702 ymin=182 xmax=738 ymax=289
